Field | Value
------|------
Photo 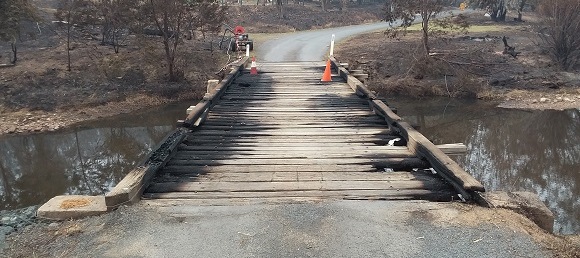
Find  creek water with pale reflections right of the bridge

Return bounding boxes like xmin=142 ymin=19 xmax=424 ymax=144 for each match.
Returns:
xmin=389 ymin=99 xmax=580 ymax=234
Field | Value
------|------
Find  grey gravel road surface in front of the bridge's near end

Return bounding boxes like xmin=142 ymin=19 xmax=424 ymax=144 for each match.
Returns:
xmin=7 ymin=200 xmax=550 ymax=257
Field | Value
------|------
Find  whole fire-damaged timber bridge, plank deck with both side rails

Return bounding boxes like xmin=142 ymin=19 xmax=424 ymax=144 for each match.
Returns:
xmin=105 ymin=57 xmax=485 ymax=209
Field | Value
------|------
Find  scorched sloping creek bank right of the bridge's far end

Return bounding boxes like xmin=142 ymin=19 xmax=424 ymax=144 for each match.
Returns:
xmin=335 ymin=10 xmax=580 ymax=110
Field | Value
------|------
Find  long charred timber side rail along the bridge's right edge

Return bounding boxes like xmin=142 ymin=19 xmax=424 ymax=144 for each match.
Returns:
xmin=330 ymin=57 xmax=485 ymax=200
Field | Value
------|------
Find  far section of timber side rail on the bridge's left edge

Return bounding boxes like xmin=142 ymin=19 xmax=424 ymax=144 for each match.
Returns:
xmin=178 ymin=56 xmax=250 ymax=128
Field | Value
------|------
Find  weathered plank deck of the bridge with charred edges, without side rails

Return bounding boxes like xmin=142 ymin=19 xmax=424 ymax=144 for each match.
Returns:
xmin=143 ymin=62 xmax=457 ymax=201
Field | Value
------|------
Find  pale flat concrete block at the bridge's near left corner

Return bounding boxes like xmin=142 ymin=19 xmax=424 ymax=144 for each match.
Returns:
xmin=36 ymin=195 xmax=107 ymax=220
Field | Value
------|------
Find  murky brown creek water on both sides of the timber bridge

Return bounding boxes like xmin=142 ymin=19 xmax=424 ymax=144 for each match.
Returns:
xmin=0 ymin=98 xmax=580 ymax=234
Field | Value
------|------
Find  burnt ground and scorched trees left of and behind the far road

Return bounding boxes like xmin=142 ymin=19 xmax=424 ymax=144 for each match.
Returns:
xmin=0 ymin=0 xmax=390 ymax=113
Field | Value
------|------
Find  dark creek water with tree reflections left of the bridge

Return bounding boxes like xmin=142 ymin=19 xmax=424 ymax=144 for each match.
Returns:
xmin=0 ymin=103 xmax=187 ymax=209
